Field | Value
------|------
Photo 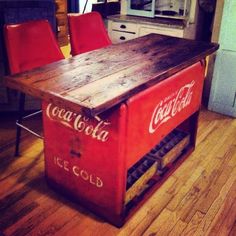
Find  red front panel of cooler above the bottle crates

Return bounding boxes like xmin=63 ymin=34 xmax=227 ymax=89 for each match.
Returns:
xmin=126 ymin=63 xmax=204 ymax=169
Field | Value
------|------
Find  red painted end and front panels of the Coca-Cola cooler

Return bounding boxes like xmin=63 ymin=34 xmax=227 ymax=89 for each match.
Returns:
xmin=43 ymin=63 xmax=204 ymax=219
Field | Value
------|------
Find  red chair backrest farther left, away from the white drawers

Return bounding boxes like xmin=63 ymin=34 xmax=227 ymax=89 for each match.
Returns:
xmin=4 ymin=20 xmax=64 ymax=74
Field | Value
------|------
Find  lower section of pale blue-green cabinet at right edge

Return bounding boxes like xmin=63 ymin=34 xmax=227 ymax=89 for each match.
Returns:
xmin=209 ymin=50 xmax=236 ymax=116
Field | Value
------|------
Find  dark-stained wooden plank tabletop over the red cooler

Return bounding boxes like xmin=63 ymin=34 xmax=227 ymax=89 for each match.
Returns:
xmin=5 ymin=34 xmax=218 ymax=116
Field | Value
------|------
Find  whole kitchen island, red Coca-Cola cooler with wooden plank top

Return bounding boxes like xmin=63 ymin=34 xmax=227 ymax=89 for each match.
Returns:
xmin=6 ymin=34 xmax=218 ymax=226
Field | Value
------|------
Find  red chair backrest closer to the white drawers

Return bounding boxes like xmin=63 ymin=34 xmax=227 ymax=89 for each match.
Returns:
xmin=68 ymin=12 xmax=111 ymax=56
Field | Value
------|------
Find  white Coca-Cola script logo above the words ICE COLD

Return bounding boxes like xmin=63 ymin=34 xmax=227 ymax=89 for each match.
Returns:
xmin=46 ymin=103 xmax=110 ymax=142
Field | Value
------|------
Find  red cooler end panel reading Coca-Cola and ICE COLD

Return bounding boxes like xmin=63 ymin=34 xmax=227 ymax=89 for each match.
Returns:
xmin=43 ymin=103 xmax=126 ymax=215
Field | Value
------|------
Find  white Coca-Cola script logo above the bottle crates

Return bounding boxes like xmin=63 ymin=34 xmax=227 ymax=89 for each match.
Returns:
xmin=149 ymin=80 xmax=195 ymax=134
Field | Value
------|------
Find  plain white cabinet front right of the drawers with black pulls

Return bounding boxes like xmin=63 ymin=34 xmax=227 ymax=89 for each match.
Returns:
xmin=139 ymin=26 xmax=184 ymax=38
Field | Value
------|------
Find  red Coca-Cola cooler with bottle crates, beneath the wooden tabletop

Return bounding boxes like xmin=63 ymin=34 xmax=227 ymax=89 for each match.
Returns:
xmin=43 ymin=62 xmax=204 ymax=226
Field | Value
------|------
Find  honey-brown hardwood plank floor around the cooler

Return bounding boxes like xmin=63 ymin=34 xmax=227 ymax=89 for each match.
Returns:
xmin=0 ymin=110 xmax=236 ymax=236
